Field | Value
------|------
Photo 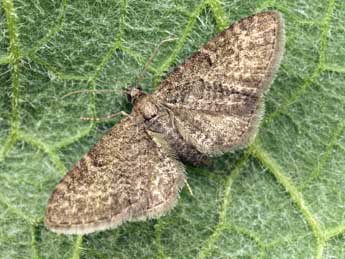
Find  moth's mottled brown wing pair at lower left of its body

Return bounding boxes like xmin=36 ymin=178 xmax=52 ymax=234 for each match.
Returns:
xmin=45 ymin=115 xmax=185 ymax=234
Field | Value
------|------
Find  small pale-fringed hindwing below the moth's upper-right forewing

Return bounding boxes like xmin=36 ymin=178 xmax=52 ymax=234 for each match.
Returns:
xmin=174 ymin=109 xmax=262 ymax=156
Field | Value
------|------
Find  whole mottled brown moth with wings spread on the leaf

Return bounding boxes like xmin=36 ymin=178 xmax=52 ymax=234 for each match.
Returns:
xmin=45 ymin=11 xmax=284 ymax=234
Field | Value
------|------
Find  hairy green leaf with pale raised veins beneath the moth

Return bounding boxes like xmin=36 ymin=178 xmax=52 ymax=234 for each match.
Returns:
xmin=0 ymin=0 xmax=345 ymax=259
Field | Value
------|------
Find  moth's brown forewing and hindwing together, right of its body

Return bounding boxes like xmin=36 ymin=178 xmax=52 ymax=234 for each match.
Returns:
xmin=154 ymin=12 xmax=284 ymax=155
